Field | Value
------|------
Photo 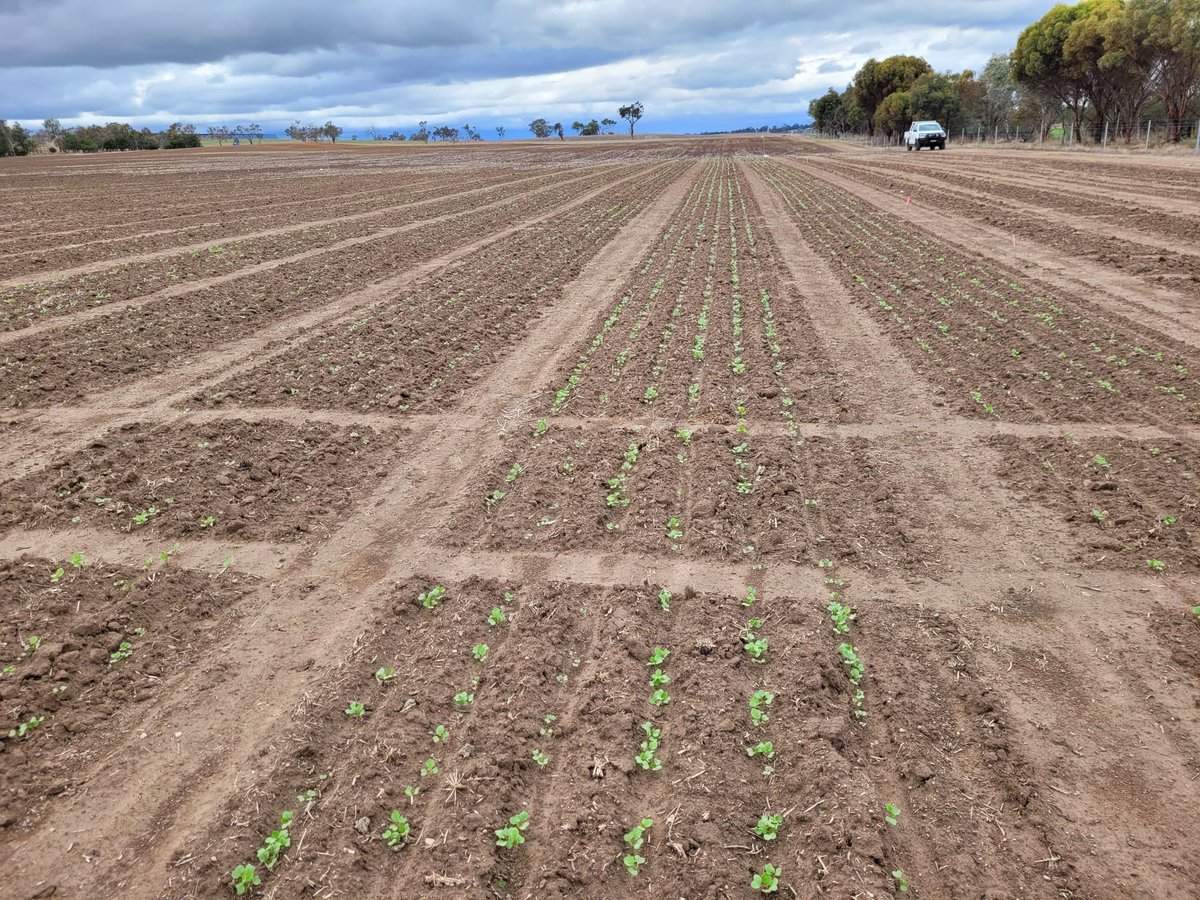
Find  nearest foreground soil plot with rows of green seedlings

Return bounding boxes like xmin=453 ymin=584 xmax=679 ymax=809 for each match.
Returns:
xmin=164 ymin=577 xmax=902 ymax=895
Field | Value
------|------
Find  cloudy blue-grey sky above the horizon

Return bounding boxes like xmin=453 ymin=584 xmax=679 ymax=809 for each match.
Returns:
xmin=0 ymin=0 xmax=1051 ymax=137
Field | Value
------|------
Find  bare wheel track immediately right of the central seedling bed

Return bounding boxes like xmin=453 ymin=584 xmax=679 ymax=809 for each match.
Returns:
xmin=749 ymin=160 xmax=1200 ymax=898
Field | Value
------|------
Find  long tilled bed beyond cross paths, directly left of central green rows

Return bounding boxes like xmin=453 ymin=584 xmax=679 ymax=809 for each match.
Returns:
xmin=208 ymin=162 xmax=688 ymax=412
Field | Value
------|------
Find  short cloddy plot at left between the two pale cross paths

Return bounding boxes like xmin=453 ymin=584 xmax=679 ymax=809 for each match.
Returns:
xmin=0 ymin=420 xmax=391 ymax=541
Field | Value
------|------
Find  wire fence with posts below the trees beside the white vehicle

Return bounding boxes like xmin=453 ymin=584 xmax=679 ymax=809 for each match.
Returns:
xmin=809 ymin=119 xmax=1200 ymax=156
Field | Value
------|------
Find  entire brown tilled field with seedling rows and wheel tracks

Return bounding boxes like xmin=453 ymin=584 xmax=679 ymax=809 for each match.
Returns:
xmin=0 ymin=136 xmax=1200 ymax=900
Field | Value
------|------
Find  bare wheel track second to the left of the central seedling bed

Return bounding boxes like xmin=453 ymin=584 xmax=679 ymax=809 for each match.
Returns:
xmin=0 ymin=162 xmax=676 ymax=487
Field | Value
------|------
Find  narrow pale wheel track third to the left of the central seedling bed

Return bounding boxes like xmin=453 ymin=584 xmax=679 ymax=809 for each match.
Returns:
xmin=0 ymin=162 xmax=616 ymax=347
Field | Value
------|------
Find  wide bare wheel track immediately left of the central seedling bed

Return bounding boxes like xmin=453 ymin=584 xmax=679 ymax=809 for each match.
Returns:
xmin=0 ymin=158 xmax=698 ymax=896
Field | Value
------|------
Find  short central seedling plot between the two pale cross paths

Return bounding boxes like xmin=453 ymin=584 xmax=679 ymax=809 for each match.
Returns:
xmin=450 ymin=420 xmax=936 ymax=570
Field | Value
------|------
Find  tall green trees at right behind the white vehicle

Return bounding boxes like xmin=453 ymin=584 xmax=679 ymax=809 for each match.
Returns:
xmin=809 ymin=0 xmax=1200 ymax=140
